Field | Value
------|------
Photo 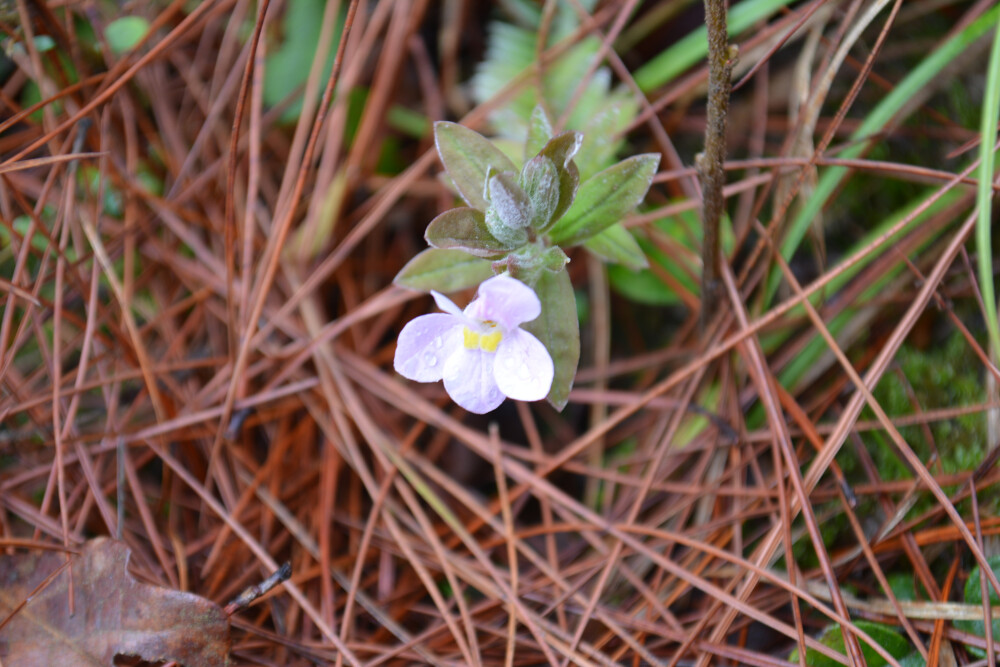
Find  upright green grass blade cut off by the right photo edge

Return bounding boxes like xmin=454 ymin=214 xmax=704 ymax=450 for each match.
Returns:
xmin=976 ymin=18 xmax=1000 ymax=360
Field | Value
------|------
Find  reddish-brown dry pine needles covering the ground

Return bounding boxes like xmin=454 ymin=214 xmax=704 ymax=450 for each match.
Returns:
xmin=0 ymin=0 xmax=1000 ymax=664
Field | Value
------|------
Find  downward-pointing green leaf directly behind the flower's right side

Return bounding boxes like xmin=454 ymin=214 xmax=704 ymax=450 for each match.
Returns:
xmin=523 ymin=267 xmax=580 ymax=410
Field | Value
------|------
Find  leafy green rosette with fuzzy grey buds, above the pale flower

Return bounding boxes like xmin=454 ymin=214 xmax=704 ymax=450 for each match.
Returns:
xmin=395 ymin=107 xmax=660 ymax=409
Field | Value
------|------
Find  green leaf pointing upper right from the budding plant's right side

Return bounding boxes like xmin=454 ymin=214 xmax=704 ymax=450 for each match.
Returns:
xmin=549 ymin=153 xmax=660 ymax=246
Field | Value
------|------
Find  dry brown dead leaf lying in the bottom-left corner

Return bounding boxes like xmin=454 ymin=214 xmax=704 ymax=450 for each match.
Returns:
xmin=0 ymin=538 xmax=229 ymax=667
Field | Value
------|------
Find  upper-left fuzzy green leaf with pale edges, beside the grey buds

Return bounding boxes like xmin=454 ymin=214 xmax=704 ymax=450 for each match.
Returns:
xmin=434 ymin=120 xmax=517 ymax=211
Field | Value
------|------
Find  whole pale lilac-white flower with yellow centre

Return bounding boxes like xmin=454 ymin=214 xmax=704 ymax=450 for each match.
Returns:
xmin=394 ymin=274 xmax=554 ymax=414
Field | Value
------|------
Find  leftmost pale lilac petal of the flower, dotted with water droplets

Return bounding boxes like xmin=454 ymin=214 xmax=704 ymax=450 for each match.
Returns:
xmin=393 ymin=313 xmax=464 ymax=382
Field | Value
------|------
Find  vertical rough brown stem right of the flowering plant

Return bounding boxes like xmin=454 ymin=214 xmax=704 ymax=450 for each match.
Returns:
xmin=696 ymin=0 xmax=736 ymax=331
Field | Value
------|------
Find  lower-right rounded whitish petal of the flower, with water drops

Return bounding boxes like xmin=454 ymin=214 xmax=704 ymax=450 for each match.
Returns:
xmin=493 ymin=329 xmax=555 ymax=401
